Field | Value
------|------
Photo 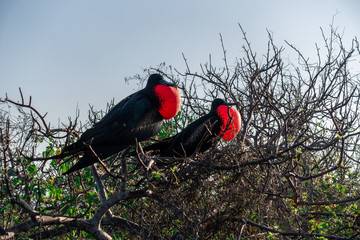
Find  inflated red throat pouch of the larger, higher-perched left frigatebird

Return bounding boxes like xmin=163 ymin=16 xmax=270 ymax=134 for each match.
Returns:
xmin=154 ymin=84 xmax=181 ymax=120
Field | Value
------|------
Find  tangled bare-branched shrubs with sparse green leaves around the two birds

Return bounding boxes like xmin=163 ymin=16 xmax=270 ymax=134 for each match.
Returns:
xmin=0 ymin=25 xmax=360 ymax=239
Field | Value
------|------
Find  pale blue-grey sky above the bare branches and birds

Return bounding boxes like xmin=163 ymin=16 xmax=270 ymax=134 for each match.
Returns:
xmin=0 ymin=0 xmax=360 ymax=126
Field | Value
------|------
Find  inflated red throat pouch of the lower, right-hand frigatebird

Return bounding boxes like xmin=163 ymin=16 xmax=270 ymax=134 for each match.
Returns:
xmin=217 ymin=105 xmax=241 ymax=141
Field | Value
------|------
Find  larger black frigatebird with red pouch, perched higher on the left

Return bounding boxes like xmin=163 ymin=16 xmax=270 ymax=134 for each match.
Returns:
xmin=62 ymin=74 xmax=181 ymax=174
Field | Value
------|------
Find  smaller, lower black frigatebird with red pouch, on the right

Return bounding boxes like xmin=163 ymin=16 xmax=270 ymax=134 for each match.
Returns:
xmin=144 ymin=98 xmax=241 ymax=157
